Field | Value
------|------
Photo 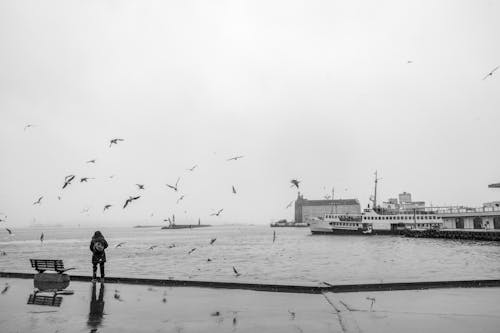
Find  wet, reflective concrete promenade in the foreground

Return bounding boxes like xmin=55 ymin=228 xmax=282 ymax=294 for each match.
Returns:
xmin=0 ymin=273 xmax=500 ymax=333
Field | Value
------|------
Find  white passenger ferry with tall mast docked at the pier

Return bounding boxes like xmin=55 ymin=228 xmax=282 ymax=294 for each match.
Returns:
xmin=306 ymin=172 xmax=443 ymax=235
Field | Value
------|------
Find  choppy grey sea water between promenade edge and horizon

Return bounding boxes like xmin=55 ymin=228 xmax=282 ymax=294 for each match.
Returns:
xmin=0 ymin=226 xmax=500 ymax=283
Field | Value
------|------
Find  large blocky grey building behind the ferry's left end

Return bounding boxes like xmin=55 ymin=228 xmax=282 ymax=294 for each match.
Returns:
xmin=295 ymin=192 xmax=361 ymax=222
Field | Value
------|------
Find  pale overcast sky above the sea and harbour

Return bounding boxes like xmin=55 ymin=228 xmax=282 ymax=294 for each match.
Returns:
xmin=0 ymin=0 xmax=500 ymax=226
